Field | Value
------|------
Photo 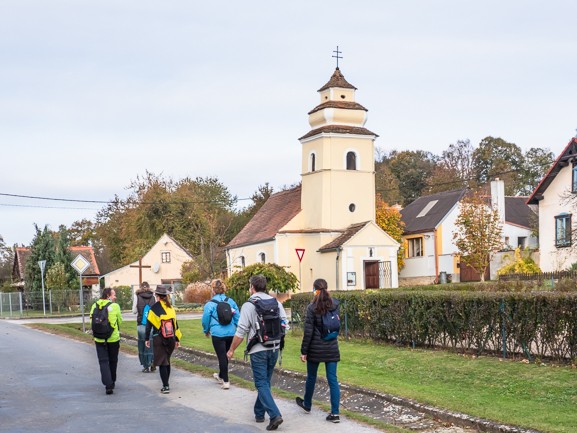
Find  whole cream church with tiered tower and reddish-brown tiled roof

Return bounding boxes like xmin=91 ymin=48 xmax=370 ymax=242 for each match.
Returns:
xmin=226 ymin=66 xmax=399 ymax=291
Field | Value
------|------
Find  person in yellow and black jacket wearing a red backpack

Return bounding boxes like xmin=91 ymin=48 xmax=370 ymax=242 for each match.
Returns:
xmin=145 ymin=284 xmax=182 ymax=394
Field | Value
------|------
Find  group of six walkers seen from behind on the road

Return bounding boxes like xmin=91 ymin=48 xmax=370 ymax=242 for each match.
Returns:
xmin=91 ymin=275 xmax=340 ymax=430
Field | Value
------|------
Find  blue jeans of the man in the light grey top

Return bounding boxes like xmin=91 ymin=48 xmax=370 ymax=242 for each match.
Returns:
xmin=250 ymin=350 xmax=280 ymax=419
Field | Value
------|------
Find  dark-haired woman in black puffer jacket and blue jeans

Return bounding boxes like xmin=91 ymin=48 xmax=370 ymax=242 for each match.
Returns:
xmin=296 ymin=278 xmax=341 ymax=423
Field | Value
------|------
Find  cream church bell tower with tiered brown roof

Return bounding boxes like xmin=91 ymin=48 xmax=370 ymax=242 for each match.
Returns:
xmin=299 ymin=66 xmax=377 ymax=229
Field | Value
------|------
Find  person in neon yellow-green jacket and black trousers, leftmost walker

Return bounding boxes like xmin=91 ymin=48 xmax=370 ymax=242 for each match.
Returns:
xmin=90 ymin=288 xmax=122 ymax=394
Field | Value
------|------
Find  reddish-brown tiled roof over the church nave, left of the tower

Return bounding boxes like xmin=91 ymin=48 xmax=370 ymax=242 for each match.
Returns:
xmin=226 ymin=186 xmax=301 ymax=249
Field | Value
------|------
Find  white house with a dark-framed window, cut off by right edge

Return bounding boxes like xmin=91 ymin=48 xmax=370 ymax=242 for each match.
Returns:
xmin=527 ymin=138 xmax=577 ymax=272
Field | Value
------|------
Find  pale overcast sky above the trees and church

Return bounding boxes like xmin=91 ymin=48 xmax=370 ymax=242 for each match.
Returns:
xmin=0 ymin=0 xmax=577 ymax=245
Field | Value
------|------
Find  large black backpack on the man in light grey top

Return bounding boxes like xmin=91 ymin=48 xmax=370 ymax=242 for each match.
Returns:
xmin=246 ymin=298 xmax=284 ymax=352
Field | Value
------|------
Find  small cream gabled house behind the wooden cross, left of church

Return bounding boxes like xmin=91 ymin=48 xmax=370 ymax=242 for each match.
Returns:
xmin=103 ymin=233 xmax=194 ymax=287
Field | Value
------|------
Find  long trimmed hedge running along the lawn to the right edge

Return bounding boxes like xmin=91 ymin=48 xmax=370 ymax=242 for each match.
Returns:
xmin=291 ymin=290 xmax=577 ymax=362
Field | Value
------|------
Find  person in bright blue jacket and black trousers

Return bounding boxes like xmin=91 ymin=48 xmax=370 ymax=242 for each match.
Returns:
xmin=202 ymin=279 xmax=240 ymax=389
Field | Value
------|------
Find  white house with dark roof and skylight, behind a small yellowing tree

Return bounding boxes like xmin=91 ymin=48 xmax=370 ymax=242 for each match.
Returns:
xmin=399 ymin=179 xmax=537 ymax=285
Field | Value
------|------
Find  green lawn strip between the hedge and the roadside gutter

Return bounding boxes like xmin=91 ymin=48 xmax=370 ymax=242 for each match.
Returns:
xmin=99 ymin=320 xmax=577 ymax=433
